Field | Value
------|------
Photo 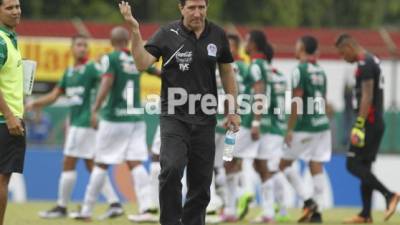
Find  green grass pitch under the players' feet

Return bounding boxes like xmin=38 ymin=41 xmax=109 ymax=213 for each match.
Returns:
xmin=5 ymin=202 xmax=400 ymax=225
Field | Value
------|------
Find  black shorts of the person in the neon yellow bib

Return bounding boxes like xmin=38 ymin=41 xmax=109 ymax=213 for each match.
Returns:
xmin=0 ymin=123 xmax=26 ymax=174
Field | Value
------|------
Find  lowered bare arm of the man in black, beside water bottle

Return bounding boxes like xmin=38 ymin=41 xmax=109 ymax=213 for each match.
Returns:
xmin=219 ymin=63 xmax=240 ymax=132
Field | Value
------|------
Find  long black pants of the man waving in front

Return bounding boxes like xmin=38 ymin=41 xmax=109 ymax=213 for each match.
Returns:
xmin=159 ymin=117 xmax=215 ymax=225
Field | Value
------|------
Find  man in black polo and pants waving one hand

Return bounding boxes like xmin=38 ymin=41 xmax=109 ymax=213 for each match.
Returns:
xmin=119 ymin=0 xmax=240 ymax=225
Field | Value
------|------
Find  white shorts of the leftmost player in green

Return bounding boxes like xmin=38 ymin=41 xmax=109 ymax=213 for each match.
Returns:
xmin=64 ymin=126 xmax=96 ymax=159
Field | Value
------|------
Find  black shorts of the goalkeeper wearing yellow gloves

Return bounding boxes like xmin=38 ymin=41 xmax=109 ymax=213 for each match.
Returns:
xmin=349 ymin=121 xmax=385 ymax=162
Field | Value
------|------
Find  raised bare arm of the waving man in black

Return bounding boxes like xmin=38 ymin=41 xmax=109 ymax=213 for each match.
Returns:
xmin=119 ymin=1 xmax=157 ymax=71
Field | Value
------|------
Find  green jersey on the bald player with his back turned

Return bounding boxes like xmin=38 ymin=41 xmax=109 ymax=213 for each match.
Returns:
xmin=101 ymin=51 xmax=143 ymax=122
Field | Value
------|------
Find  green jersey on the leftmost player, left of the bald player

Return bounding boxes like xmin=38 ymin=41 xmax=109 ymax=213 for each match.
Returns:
xmin=58 ymin=62 xmax=101 ymax=127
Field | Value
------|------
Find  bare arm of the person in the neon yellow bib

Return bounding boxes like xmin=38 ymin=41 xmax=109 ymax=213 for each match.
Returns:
xmin=0 ymin=91 xmax=24 ymax=136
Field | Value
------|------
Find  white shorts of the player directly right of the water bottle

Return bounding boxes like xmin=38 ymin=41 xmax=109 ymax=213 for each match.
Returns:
xmin=233 ymin=127 xmax=259 ymax=159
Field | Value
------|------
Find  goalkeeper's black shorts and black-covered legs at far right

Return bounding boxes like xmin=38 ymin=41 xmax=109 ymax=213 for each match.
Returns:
xmin=347 ymin=122 xmax=393 ymax=217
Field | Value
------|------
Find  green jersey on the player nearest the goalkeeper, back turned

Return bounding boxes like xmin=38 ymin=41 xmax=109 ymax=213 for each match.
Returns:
xmin=292 ymin=62 xmax=329 ymax=132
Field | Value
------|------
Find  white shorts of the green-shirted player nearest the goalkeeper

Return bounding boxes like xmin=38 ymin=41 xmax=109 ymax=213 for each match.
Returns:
xmin=282 ymin=130 xmax=332 ymax=162
